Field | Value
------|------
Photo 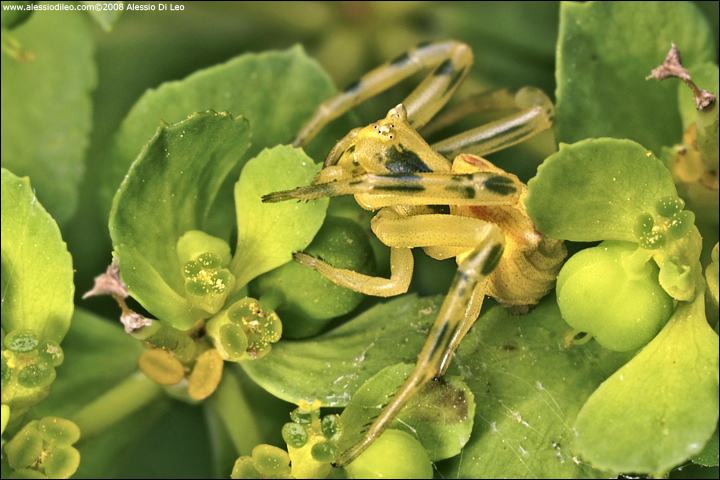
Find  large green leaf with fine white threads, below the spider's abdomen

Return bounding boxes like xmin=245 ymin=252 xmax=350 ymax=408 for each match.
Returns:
xmin=454 ymin=296 xmax=628 ymax=478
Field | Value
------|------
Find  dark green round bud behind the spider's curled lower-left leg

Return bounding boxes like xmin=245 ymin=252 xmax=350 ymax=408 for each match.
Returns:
xmin=250 ymin=216 xmax=376 ymax=338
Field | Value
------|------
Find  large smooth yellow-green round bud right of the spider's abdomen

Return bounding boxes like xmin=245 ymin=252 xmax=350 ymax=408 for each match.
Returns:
xmin=557 ymin=241 xmax=674 ymax=351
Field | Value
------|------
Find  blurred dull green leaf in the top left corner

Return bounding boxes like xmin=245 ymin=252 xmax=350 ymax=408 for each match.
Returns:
xmin=0 ymin=7 xmax=96 ymax=225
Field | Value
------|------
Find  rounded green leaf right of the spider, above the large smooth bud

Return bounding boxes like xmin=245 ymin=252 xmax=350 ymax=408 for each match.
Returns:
xmin=525 ymin=138 xmax=677 ymax=242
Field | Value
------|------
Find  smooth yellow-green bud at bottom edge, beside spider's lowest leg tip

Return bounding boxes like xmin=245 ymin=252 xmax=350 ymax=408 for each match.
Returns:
xmin=345 ymin=429 xmax=433 ymax=478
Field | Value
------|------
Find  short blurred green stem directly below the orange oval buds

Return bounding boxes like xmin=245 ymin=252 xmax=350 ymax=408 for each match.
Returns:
xmin=208 ymin=364 xmax=261 ymax=455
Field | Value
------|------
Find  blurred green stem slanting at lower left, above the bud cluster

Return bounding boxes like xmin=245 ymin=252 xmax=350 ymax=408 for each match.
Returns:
xmin=70 ymin=371 xmax=163 ymax=442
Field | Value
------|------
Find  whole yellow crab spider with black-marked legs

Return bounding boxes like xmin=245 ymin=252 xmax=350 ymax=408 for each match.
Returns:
xmin=263 ymin=41 xmax=566 ymax=466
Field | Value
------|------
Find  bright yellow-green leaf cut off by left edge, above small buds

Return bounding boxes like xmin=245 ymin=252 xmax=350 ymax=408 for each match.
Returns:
xmin=2 ymin=168 xmax=75 ymax=343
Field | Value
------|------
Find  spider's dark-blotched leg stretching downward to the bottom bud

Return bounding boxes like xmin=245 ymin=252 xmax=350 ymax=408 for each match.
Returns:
xmin=335 ymin=223 xmax=505 ymax=466
